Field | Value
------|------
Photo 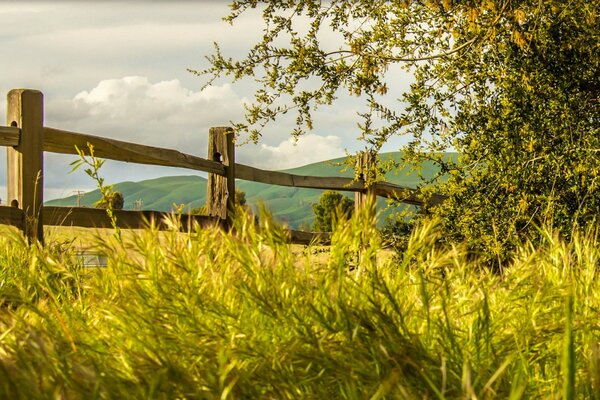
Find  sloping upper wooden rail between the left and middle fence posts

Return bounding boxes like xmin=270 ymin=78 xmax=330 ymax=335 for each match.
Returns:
xmin=44 ymin=127 xmax=225 ymax=175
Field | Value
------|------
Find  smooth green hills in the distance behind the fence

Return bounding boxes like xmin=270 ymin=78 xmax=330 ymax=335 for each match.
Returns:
xmin=45 ymin=152 xmax=455 ymax=228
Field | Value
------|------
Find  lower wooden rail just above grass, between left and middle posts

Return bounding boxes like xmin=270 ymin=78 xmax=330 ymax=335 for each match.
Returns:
xmin=43 ymin=206 xmax=221 ymax=230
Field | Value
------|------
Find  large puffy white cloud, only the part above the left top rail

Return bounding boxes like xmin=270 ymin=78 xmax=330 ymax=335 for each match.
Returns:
xmin=46 ymin=76 xmax=243 ymax=148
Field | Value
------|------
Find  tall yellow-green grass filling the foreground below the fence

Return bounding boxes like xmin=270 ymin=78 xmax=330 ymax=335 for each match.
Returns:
xmin=0 ymin=208 xmax=600 ymax=399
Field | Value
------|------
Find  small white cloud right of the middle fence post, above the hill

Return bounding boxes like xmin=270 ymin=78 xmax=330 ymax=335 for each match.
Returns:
xmin=237 ymin=134 xmax=345 ymax=170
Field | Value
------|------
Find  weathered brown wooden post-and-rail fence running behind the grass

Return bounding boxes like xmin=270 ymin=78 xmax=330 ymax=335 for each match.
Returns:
xmin=0 ymin=89 xmax=443 ymax=244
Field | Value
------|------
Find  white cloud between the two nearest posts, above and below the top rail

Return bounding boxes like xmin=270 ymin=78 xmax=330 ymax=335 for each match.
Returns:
xmin=29 ymin=76 xmax=244 ymax=198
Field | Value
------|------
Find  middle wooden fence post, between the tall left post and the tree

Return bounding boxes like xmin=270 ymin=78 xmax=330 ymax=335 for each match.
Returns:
xmin=206 ymin=127 xmax=235 ymax=229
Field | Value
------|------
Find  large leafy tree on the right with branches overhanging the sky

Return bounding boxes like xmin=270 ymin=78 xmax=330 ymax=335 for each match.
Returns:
xmin=199 ymin=0 xmax=600 ymax=258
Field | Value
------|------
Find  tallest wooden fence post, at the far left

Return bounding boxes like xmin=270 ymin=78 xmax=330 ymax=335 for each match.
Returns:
xmin=6 ymin=89 xmax=44 ymax=244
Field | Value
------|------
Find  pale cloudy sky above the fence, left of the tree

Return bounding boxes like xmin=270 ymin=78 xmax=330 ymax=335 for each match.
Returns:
xmin=0 ymin=1 xmax=408 ymax=199
